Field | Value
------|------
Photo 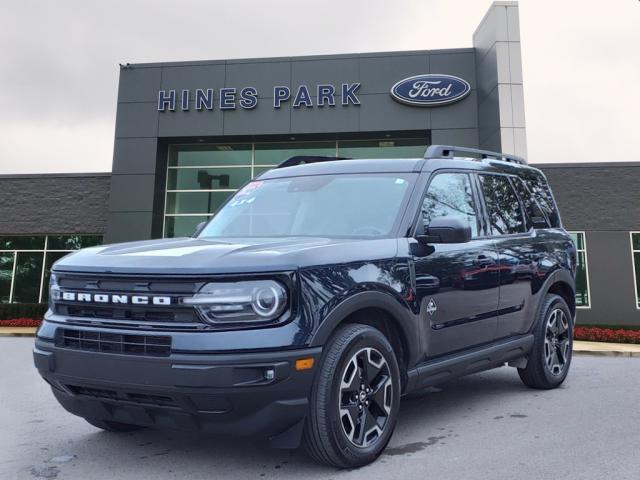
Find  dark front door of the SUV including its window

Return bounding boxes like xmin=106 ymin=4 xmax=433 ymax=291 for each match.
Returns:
xmin=414 ymin=172 xmax=499 ymax=357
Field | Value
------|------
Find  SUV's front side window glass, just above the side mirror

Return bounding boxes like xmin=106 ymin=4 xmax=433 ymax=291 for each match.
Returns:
xmin=422 ymin=173 xmax=478 ymax=237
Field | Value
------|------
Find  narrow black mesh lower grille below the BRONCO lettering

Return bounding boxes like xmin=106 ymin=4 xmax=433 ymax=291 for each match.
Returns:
xmin=56 ymin=328 xmax=171 ymax=357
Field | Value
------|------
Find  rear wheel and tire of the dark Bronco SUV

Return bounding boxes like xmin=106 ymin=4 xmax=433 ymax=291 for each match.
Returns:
xmin=518 ymin=294 xmax=573 ymax=390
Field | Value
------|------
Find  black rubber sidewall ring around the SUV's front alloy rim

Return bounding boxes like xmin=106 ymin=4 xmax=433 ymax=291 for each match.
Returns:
xmin=325 ymin=328 xmax=400 ymax=465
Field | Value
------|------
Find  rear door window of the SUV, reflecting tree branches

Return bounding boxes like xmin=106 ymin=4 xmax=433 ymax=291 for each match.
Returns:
xmin=479 ymin=174 xmax=527 ymax=235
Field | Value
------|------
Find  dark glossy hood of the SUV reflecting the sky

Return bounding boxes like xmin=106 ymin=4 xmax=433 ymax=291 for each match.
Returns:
xmin=53 ymin=237 xmax=397 ymax=275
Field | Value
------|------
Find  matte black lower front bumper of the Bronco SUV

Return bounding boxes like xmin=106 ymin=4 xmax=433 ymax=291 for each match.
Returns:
xmin=33 ymin=338 xmax=321 ymax=448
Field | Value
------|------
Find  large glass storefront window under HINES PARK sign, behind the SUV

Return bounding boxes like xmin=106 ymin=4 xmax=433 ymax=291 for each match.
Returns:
xmin=164 ymin=133 xmax=428 ymax=237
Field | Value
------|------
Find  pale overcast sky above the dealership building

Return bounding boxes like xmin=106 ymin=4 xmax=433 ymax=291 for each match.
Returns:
xmin=0 ymin=0 xmax=640 ymax=174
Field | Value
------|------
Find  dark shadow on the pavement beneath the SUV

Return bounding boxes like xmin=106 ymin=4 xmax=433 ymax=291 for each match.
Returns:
xmin=63 ymin=368 xmax=536 ymax=472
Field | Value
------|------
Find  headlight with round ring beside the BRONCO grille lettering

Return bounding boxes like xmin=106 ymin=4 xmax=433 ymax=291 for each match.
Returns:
xmin=182 ymin=280 xmax=287 ymax=323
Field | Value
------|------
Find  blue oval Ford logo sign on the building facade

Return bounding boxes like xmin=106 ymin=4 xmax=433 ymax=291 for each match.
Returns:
xmin=391 ymin=74 xmax=471 ymax=107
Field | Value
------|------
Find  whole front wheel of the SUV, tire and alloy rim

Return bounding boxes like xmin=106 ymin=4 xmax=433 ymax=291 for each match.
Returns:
xmin=304 ymin=324 xmax=401 ymax=468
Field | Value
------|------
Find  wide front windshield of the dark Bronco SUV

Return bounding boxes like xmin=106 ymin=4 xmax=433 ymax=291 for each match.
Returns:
xmin=199 ymin=173 xmax=415 ymax=238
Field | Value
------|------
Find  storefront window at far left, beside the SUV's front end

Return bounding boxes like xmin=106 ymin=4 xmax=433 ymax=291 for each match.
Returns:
xmin=0 ymin=235 xmax=102 ymax=303
